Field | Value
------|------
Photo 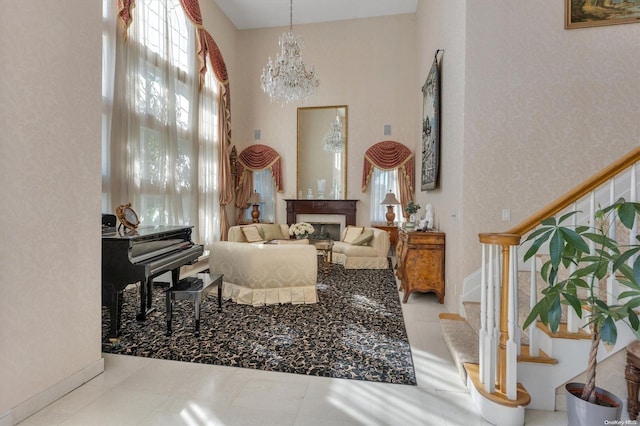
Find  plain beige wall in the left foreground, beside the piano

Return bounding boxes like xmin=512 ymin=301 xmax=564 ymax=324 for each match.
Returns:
xmin=0 ymin=0 xmax=102 ymax=423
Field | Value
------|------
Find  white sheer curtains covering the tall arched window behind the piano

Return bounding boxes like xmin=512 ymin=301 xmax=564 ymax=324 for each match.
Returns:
xmin=103 ymin=0 xmax=219 ymax=243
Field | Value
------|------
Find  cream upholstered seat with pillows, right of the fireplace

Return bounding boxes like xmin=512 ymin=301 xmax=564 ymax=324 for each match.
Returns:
xmin=333 ymin=226 xmax=391 ymax=269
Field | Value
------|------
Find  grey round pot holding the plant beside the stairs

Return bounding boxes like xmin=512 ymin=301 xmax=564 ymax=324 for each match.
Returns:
xmin=565 ymin=383 xmax=622 ymax=426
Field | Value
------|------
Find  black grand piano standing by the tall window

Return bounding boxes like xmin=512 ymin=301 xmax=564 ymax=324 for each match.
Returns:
xmin=102 ymin=226 xmax=203 ymax=339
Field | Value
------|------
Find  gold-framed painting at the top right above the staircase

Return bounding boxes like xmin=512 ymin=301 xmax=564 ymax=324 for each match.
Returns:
xmin=564 ymin=0 xmax=640 ymax=29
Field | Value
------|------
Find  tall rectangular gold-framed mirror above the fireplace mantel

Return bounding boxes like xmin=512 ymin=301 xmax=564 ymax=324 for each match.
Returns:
xmin=297 ymin=105 xmax=348 ymax=200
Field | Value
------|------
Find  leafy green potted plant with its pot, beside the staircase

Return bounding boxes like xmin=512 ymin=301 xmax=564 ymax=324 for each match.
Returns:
xmin=523 ymin=199 xmax=640 ymax=425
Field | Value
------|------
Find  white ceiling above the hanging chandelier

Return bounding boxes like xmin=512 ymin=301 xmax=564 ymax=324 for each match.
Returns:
xmin=215 ymin=0 xmax=418 ymax=30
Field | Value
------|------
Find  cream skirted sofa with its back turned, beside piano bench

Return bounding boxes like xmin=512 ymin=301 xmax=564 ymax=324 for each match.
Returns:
xmin=209 ymin=241 xmax=318 ymax=306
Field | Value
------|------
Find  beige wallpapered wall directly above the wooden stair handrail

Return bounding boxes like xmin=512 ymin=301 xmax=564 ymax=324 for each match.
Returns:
xmin=460 ymin=0 xmax=640 ymax=282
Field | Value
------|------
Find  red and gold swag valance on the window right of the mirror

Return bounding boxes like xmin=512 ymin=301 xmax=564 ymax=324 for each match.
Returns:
xmin=362 ymin=141 xmax=415 ymax=192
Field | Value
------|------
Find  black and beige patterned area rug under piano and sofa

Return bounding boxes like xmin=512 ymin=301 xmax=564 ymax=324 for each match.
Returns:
xmin=102 ymin=265 xmax=416 ymax=385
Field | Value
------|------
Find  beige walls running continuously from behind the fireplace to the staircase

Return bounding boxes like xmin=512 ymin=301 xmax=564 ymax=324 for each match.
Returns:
xmin=232 ymin=0 xmax=640 ymax=310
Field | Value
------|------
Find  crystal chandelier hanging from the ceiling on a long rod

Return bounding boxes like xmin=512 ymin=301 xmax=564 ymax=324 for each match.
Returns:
xmin=260 ymin=0 xmax=320 ymax=104
